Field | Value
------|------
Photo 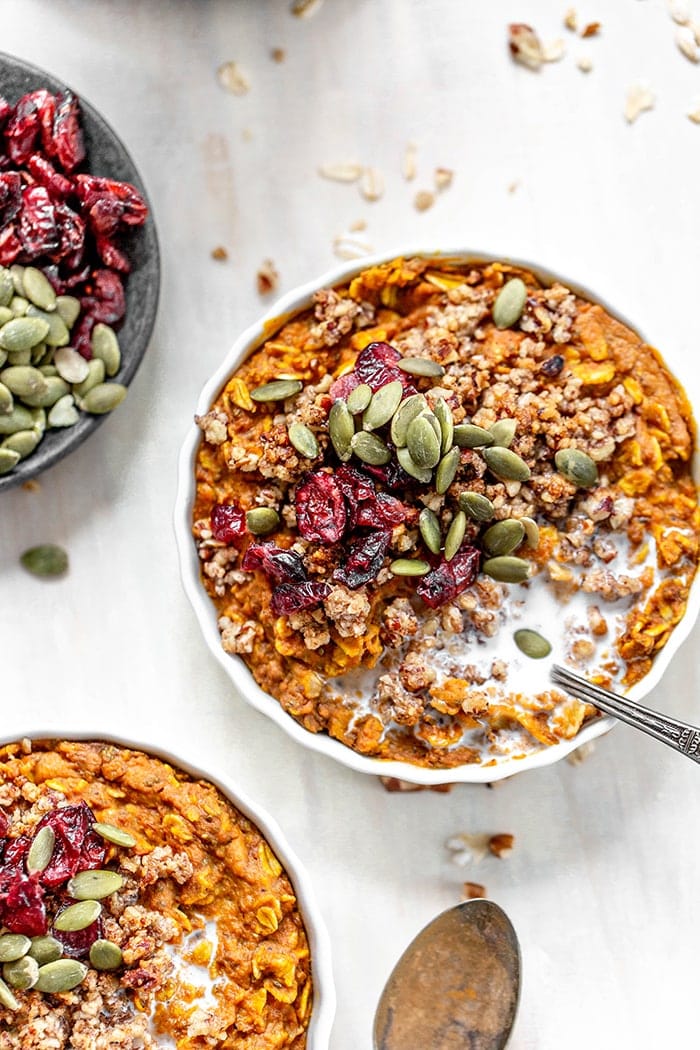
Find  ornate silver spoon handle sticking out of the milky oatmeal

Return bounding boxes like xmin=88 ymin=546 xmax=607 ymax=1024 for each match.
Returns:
xmin=552 ymin=664 xmax=700 ymax=762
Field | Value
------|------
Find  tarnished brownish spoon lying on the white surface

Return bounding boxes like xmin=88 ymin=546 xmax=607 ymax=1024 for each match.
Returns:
xmin=374 ymin=900 xmax=521 ymax=1050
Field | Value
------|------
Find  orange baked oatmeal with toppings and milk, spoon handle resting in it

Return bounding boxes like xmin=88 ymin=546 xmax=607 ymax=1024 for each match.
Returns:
xmin=193 ymin=258 xmax=700 ymax=769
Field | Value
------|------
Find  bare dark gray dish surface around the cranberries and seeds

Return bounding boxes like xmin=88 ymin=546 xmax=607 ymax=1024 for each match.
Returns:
xmin=0 ymin=53 xmax=161 ymax=491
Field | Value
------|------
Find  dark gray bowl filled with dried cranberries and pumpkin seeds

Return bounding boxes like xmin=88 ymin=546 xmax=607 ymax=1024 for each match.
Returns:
xmin=0 ymin=55 xmax=160 ymax=490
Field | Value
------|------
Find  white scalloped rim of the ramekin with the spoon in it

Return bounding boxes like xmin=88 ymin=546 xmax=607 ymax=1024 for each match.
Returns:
xmin=173 ymin=246 xmax=700 ymax=786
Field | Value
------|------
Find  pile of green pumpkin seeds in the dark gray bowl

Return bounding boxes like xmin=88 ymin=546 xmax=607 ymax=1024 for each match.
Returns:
xmin=0 ymin=265 xmax=126 ymax=475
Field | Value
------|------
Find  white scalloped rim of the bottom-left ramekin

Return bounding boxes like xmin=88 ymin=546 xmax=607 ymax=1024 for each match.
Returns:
xmin=0 ymin=722 xmax=336 ymax=1050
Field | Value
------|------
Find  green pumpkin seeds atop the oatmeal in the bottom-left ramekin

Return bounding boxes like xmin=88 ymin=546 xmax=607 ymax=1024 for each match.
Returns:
xmin=0 ymin=823 xmax=135 ymax=1010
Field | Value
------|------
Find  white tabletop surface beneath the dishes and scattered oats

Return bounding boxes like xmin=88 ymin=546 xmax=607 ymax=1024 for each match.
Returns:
xmin=0 ymin=0 xmax=700 ymax=1050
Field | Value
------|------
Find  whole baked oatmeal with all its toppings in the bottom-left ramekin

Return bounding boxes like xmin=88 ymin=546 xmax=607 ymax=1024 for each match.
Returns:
xmin=0 ymin=740 xmax=312 ymax=1050
